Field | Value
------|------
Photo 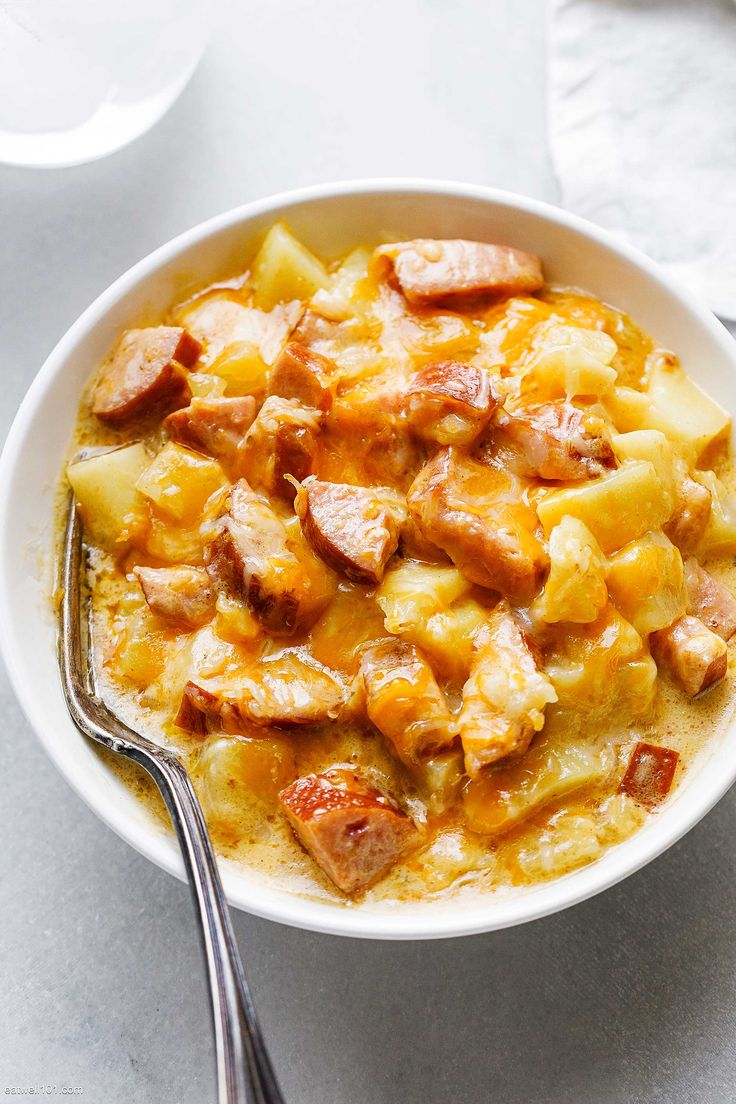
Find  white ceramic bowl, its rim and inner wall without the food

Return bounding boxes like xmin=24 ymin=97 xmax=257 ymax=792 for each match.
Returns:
xmin=0 ymin=180 xmax=736 ymax=938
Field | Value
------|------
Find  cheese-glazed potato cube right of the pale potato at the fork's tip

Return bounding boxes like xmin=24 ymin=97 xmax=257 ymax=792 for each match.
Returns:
xmin=136 ymin=442 xmax=226 ymax=524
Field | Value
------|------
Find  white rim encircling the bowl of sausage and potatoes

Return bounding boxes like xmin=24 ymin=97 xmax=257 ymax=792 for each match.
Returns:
xmin=0 ymin=177 xmax=736 ymax=940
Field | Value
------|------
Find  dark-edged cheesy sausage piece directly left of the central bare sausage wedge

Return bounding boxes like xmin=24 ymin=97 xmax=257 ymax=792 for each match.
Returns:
xmin=205 ymin=479 xmax=317 ymax=636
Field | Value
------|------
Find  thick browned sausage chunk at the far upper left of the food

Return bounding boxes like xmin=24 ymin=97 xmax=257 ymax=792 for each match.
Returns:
xmin=92 ymin=326 xmax=202 ymax=424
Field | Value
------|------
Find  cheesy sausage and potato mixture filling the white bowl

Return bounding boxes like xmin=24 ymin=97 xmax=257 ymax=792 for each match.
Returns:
xmin=67 ymin=224 xmax=736 ymax=901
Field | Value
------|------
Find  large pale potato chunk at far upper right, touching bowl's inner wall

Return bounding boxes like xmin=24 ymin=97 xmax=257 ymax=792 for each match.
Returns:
xmin=644 ymin=357 xmax=730 ymax=463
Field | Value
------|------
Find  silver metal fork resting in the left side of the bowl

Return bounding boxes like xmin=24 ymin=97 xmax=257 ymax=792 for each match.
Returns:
xmin=58 ymin=496 xmax=284 ymax=1104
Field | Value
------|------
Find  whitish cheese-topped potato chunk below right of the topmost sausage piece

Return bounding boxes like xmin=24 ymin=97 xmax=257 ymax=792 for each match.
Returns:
xmin=523 ymin=326 xmax=617 ymax=399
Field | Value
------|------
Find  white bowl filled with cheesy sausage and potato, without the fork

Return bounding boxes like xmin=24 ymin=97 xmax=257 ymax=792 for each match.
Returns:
xmin=0 ymin=181 xmax=736 ymax=938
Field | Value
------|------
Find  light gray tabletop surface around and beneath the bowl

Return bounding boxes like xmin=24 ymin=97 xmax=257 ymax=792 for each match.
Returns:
xmin=0 ymin=0 xmax=736 ymax=1104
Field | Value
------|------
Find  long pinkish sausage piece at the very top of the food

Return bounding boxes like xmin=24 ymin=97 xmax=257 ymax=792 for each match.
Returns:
xmin=373 ymin=238 xmax=544 ymax=302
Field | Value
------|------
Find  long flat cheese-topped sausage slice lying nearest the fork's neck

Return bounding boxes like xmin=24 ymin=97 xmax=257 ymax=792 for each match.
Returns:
xmin=177 ymin=651 xmax=346 ymax=732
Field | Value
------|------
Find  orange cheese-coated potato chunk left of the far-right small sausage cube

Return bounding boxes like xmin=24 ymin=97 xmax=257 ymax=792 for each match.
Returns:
xmin=544 ymin=604 xmax=657 ymax=731
